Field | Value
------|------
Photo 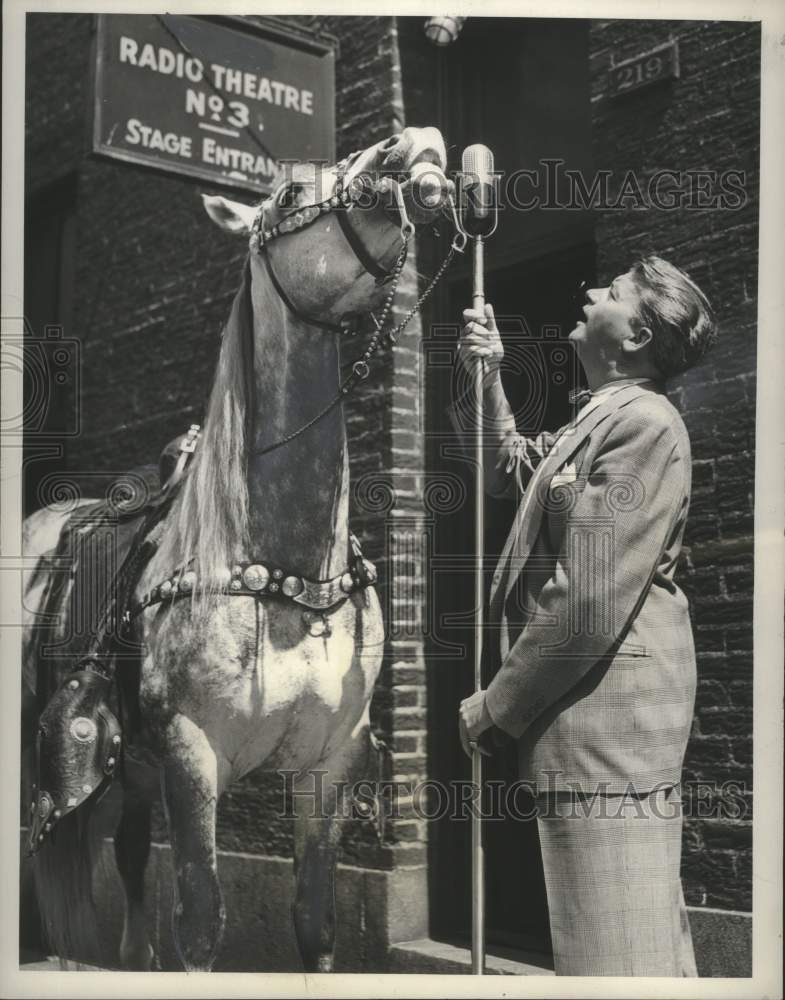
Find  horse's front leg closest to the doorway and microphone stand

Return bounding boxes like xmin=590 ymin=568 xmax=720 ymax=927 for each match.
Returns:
xmin=292 ymin=720 xmax=371 ymax=972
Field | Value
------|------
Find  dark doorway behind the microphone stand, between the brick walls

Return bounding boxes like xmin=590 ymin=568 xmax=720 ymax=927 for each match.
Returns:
xmin=424 ymin=18 xmax=594 ymax=962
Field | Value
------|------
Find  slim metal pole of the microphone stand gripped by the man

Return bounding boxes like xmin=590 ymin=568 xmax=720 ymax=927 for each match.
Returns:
xmin=472 ymin=236 xmax=485 ymax=976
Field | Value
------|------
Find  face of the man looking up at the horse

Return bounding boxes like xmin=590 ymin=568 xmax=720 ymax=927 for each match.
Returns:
xmin=568 ymin=274 xmax=640 ymax=359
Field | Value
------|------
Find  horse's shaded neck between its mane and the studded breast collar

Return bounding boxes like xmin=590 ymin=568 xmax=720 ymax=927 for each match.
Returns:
xmin=247 ymin=269 xmax=349 ymax=579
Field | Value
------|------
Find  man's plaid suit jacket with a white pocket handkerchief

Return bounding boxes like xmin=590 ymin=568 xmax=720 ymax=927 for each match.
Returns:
xmin=452 ymin=384 xmax=696 ymax=794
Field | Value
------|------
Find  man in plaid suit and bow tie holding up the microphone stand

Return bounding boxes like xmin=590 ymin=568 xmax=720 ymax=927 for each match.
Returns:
xmin=453 ymin=257 xmax=716 ymax=976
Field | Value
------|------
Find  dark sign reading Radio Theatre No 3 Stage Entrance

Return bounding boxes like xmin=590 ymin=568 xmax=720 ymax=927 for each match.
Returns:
xmin=93 ymin=14 xmax=335 ymax=193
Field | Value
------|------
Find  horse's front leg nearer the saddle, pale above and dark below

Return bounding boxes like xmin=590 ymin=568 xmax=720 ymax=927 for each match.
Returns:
xmin=162 ymin=715 xmax=226 ymax=972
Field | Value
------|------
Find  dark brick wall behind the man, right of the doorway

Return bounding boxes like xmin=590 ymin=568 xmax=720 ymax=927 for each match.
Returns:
xmin=591 ymin=21 xmax=760 ymax=910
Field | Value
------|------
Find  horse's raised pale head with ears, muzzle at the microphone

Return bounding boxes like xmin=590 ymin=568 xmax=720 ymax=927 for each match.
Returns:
xmin=204 ymin=128 xmax=452 ymax=323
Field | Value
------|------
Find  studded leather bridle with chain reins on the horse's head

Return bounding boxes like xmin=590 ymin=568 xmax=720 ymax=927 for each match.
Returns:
xmin=249 ymin=153 xmax=468 ymax=455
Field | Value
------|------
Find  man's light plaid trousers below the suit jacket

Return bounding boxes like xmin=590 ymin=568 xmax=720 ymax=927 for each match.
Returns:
xmin=537 ymin=788 xmax=697 ymax=976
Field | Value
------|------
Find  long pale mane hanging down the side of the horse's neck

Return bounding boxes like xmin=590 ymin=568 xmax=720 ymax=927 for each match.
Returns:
xmin=159 ymin=259 xmax=254 ymax=598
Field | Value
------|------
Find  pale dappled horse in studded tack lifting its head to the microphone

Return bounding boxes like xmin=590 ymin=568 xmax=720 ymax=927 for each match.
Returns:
xmin=23 ymin=127 xmax=451 ymax=972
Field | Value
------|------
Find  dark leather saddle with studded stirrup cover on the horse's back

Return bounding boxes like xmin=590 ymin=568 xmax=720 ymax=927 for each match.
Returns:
xmin=28 ymin=424 xmax=199 ymax=854
